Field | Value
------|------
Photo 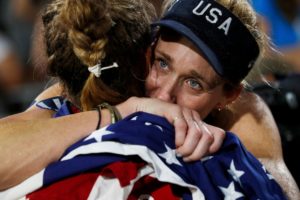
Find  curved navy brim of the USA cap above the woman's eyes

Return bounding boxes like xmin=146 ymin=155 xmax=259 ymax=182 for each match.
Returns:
xmin=152 ymin=19 xmax=224 ymax=76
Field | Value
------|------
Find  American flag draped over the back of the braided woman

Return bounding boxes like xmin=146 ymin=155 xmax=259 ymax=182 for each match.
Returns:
xmin=0 ymin=97 xmax=286 ymax=200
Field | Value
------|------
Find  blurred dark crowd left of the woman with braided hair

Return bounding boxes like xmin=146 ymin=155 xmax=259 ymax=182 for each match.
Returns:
xmin=0 ymin=0 xmax=48 ymax=117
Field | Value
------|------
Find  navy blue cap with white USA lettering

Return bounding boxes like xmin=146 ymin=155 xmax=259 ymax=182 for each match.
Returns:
xmin=152 ymin=0 xmax=259 ymax=82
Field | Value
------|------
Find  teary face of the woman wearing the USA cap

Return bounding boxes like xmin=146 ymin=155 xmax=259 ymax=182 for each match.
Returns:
xmin=146 ymin=38 xmax=239 ymax=118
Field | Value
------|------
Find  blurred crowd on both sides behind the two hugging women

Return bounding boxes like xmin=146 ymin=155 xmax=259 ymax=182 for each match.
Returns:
xmin=0 ymin=0 xmax=300 ymax=187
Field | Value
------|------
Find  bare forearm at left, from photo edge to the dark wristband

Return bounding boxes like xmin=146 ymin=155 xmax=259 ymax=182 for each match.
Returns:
xmin=0 ymin=105 xmax=98 ymax=190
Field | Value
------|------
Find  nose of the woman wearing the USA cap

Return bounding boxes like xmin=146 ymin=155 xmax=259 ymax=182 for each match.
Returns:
xmin=156 ymin=77 xmax=177 ymax=103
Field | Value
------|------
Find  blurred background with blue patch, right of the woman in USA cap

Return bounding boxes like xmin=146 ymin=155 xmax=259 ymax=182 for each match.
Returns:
xmin=251 ymin=0 xmax=300 ymax=186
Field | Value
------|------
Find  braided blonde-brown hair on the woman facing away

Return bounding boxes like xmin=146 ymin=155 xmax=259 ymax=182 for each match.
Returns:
xmin=43 ymin=0 xmax=156 ymax=110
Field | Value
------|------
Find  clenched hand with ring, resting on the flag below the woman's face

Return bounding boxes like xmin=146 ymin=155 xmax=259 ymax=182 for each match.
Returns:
xmin=118 ymin=97 xmax=225 ymax=161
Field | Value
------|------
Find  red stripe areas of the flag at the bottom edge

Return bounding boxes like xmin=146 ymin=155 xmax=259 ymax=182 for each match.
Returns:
xmin=26 ymin=162 xmax=183 ymax=200
